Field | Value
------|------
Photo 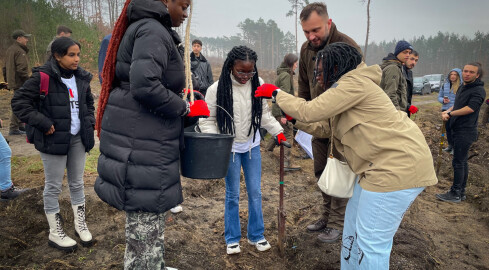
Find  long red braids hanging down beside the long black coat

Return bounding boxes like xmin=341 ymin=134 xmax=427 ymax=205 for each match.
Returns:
xmin=95 ymin=0 xmax=131 ymax=138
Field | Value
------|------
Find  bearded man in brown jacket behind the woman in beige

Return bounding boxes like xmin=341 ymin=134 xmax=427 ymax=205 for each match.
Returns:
xmin=298 ymin=2 xmax=361 ymax=243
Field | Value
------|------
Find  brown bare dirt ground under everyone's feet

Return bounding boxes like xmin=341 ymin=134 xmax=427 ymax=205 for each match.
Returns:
xmin=0 ymin=81 xmax=489 ymax=270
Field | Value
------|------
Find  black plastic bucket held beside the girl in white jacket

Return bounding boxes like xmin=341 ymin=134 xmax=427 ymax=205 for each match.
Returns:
xmin=180 ymin=132 xmax=234 ymax=179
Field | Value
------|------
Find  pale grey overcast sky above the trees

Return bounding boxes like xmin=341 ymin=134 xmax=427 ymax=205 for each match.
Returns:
xmin=191 ymin=0 xmax=489 ymax=45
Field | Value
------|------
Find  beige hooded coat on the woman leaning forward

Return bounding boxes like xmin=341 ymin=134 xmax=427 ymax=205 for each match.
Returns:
xmin=277 ymin=63 xmax=438 ymax=192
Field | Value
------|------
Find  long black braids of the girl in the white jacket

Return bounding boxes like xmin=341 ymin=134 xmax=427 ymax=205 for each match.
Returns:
xmin=216 ymin=46 xmax=262 ymax=141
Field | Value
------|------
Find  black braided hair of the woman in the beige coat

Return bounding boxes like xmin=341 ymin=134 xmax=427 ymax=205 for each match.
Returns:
xmin=316 ymin=42 xmax=362 ymax=85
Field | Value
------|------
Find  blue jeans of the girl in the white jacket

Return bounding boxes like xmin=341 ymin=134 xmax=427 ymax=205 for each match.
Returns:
xmin=224 ymin=146 xmax=265 ymax=244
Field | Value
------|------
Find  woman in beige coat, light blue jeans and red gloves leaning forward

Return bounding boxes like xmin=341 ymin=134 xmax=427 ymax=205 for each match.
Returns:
xmin=255 ymin=42 xmax=438 ymax=270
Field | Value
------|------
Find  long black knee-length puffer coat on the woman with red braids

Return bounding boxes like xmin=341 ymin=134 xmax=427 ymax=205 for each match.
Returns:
xmin=95 ymin=0 xmax=186 ymax=213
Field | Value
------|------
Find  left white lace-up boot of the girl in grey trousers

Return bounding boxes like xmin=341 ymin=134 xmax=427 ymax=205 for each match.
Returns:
xmin=46 ymin=213 xmax=77 ymax=251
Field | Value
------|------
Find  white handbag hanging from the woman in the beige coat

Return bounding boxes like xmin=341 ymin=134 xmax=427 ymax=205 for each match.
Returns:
xmin=318 ymin=119 xmax=357 ymax=198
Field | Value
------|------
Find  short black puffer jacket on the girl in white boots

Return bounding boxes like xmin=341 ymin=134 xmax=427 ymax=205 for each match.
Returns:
xmin=12 ymin=60 xmax=95 ymax=155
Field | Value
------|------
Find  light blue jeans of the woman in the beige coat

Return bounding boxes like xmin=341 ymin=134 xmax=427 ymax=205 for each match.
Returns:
xmin=341 ymin=179 xmax=424 ymax=270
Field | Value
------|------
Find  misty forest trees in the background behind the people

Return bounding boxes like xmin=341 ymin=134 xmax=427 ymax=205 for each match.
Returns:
xmin=0 ymin=0 xmax=489 ymax=79
